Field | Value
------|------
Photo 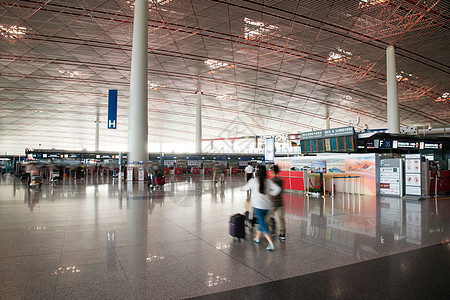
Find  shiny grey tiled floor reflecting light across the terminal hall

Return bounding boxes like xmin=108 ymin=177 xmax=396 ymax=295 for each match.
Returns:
xmin=0 ymin=175 xmax=450 ymax=299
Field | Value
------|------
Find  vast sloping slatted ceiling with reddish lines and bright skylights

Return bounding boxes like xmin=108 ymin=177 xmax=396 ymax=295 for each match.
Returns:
xmin=0 ymin=0 xmax=450 ymax=154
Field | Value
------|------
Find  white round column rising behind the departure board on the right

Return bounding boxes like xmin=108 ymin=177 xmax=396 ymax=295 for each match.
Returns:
xmin=386 ymin=45 xmax=400 ymax=133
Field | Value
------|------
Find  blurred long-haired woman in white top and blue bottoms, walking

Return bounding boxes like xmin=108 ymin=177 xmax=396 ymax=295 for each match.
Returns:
xmin=241 ymin=165 xmax=281 ymax=251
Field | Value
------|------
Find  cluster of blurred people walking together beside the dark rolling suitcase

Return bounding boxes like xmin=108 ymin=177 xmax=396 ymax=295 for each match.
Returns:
xmin=241 ymin=163 xmax=286 ymax=251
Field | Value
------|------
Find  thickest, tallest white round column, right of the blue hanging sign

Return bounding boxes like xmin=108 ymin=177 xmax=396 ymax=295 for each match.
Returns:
xmin=128 ymin=0 xmax=148 ymax=167
